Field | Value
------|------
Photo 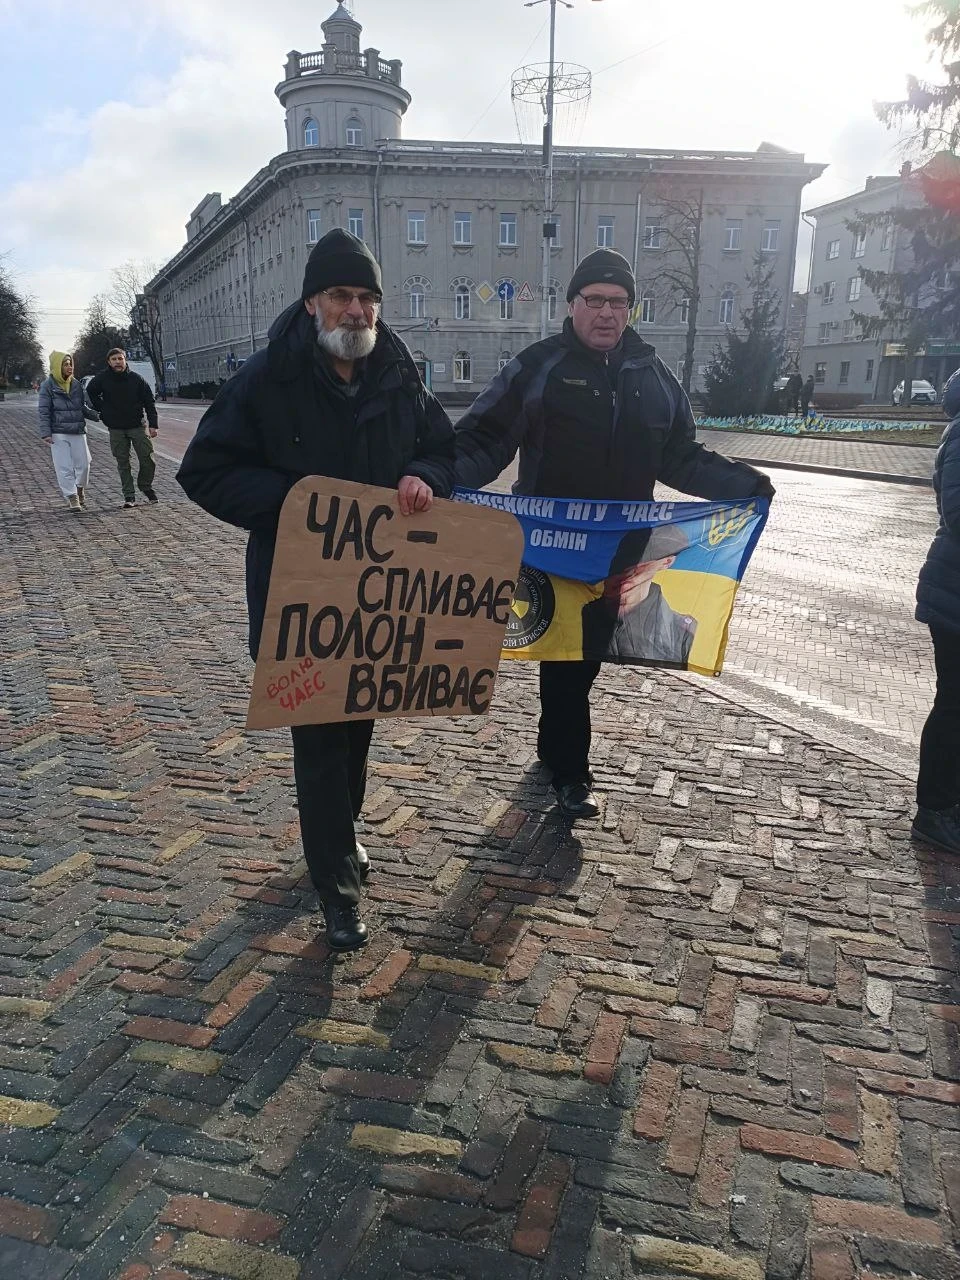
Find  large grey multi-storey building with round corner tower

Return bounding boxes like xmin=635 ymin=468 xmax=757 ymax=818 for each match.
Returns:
xmin=148 ymin=5 xmax=823 ymax=396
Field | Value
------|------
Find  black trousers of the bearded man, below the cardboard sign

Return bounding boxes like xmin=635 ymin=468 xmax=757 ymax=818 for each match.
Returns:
xmin=291 ymin=721 xmax=374 ymax=906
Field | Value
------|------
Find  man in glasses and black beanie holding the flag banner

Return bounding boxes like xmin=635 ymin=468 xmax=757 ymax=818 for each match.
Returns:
xmin=457 ymin=250 xmax=773 ymax=818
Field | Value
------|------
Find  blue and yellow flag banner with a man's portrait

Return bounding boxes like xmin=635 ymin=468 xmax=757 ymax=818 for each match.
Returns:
xmin=454 ymin=489 xmax=769 ymax=676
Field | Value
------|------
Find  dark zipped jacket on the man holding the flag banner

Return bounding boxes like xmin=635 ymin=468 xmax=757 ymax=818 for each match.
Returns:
xmin=457 ymin=319 xmax=773 ymax=502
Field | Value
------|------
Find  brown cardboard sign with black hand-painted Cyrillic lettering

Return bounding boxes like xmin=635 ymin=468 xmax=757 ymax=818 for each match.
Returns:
xmin=247 ymin=476 xmax=524 ymax=728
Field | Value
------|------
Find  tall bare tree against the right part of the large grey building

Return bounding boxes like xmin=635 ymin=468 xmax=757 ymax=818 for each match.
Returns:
xmin=648 ymin=187 xmax=704 ymax=394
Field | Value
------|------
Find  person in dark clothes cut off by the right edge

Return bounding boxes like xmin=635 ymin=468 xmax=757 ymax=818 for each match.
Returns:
xmin=913 ymin=372 xmax=960 ymax=854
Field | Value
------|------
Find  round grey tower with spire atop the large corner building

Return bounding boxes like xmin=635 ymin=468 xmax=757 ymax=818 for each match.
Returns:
xmin=275 ymin=4 xmax=410 ymax=151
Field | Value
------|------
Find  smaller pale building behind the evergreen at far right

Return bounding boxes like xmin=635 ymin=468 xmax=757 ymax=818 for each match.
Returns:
xmin=803 ymin=170 xmax=960 ymax=404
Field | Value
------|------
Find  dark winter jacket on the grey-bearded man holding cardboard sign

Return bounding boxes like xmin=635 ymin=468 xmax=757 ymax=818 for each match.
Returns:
xmin=177 ymin=301 xmax=453 ymax=658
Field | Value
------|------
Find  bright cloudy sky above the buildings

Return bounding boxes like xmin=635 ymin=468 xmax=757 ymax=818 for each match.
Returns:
xmin=0 ymin=0 xmax=928 ymax=349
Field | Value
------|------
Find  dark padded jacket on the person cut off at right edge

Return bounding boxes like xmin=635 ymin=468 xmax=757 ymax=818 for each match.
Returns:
xmin=916 ymin=374 xmax=960 ymax=632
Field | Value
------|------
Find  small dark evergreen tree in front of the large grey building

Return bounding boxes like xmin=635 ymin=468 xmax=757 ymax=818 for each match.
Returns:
xmin=704 ymin=253 xmax=783 ymax=417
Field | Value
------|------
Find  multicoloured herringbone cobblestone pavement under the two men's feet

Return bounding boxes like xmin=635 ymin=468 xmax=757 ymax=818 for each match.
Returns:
xmin=0 ymin=415 xmax=960 ymax=1280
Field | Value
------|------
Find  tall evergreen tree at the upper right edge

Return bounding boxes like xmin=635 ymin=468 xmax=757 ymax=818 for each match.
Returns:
xmin=849 ymin=0 xmax=960 ymax=404
